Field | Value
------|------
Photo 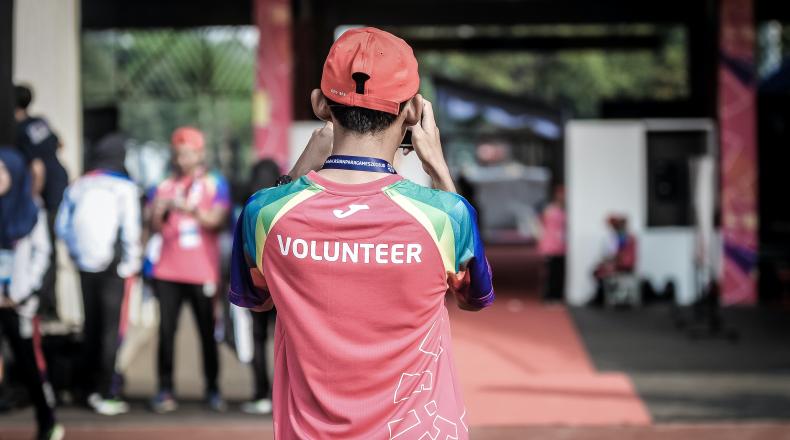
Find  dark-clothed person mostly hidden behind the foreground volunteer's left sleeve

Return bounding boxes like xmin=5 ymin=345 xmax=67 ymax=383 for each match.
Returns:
xmin=241 ymin=159 xmax=280 ymax=414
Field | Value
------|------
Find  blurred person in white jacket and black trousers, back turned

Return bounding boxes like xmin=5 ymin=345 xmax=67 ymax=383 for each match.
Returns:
xmin=56 ymin=134 xmax=142 ymax=415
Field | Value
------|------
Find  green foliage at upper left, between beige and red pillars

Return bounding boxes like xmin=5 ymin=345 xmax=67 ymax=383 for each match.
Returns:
xmin=82 ymin=27 xmax=257 ymax=169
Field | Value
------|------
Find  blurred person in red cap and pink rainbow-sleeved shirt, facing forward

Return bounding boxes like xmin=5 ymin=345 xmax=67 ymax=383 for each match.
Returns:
xmin=148 ymin=127 xmax=231 ymax=413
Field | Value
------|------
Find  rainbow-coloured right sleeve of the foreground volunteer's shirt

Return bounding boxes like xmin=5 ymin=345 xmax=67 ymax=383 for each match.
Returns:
xmin=384 ymin=180 xmax=494 ymax=310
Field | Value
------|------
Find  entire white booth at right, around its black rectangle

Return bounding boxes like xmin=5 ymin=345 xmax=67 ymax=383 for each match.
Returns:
xmin=565 ymin=119 xmax=715 ymax=305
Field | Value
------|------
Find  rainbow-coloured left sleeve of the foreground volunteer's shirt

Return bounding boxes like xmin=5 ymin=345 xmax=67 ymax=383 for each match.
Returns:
xmin=228 ymin=177 xmax=321 ymax=308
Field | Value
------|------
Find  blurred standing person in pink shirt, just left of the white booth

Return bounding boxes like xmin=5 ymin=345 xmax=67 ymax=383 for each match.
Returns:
xmin=538 ymin=185 xmax=566 ymax=302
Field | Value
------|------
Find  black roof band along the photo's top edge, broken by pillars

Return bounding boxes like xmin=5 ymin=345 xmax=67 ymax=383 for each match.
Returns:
xmin=82 ymin=0 xmax=790 ymax=29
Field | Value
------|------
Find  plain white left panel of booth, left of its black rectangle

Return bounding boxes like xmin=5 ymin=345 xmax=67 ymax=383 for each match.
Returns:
xmin=565 ymin=121 xmax=646 ymax=305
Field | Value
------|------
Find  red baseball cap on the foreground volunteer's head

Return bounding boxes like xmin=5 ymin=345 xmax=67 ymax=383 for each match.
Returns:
xmin=321 ymin=27 xmax=420 ymax=115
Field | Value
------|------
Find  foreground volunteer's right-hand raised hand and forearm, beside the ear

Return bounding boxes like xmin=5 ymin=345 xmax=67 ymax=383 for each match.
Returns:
xmin=403 ymin=99 xmax=455 ymax=192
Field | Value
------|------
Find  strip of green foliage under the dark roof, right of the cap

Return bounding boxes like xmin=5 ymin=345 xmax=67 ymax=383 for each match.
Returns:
xmin=417 ymin=26 xmax=688 ymax=117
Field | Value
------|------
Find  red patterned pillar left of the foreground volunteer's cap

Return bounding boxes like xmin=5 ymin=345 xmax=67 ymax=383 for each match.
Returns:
xmin=252 ymin=0 xmax=293 ymax=169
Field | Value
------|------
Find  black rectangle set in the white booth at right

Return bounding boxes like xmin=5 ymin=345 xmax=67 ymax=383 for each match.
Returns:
xmin=647 ymin=130 xmax=708 ymax=227
